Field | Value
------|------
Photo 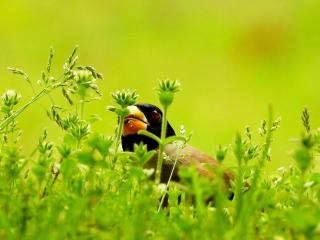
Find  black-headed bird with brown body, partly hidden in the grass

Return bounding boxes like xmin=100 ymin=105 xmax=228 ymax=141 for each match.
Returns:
xmin=122 ymin=104 xmax=234 ymax=197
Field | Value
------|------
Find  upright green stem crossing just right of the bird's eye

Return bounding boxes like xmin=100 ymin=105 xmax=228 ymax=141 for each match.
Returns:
xmin=155 ymin=106 xmax=168 ymax=184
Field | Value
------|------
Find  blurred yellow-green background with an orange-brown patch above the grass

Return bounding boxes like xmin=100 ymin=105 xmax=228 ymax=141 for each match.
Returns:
xmin=0 ymin=0 xmax=320 ymax=170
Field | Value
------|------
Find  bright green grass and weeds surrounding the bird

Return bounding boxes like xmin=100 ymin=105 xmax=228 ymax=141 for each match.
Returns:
xmin=0 ymin=48 xmax=320 ymax=239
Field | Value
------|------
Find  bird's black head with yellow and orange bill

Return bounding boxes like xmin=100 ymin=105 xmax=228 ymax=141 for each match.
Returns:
xmin=122 ymin=103 xmax=175 ymax=151
